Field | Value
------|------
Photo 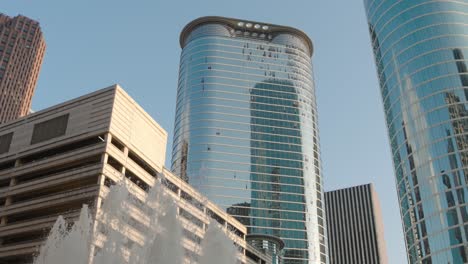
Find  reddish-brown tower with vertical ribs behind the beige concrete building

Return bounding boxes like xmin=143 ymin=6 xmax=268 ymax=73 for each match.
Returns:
xmin=0 ymin=13 xmax=46 ymax=124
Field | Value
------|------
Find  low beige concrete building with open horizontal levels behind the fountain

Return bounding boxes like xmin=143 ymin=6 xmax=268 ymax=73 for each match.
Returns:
xmin=0 ymin=85 xmax=272 ymax=264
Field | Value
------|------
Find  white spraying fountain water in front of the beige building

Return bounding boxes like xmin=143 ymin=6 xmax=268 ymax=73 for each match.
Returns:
xmin=34 ymin=180 xmax=238 ymax=264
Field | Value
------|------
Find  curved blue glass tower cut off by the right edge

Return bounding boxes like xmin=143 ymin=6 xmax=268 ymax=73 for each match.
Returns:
xmin=364 ymin=0 xmax=468 ymax=263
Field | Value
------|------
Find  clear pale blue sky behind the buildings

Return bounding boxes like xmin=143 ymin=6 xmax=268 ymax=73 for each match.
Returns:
xmin=0 ymin=0 xmax=407 ymax=263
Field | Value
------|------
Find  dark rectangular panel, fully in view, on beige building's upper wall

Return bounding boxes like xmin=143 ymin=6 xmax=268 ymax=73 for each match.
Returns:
xmin=31 ymin=114 xmax=69 ymax=145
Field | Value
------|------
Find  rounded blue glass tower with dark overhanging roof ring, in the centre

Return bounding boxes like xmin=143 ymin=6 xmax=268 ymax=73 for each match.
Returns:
xmin=172 ymin=17 xmax=327 ymax=264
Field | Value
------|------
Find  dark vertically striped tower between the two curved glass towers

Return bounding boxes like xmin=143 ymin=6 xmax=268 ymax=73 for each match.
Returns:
xmin=325 ymin=184 xmax=388 ymax=264
